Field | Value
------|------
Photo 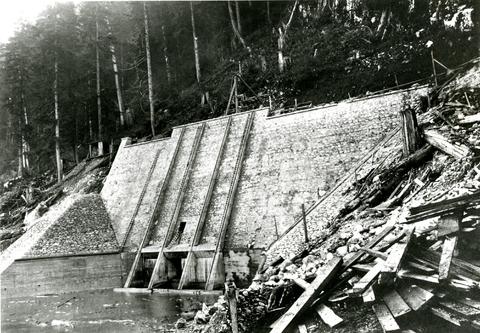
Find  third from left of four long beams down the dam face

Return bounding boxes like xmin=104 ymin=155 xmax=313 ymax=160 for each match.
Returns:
xmin=178 ymin=116 xmax=232 ymax=289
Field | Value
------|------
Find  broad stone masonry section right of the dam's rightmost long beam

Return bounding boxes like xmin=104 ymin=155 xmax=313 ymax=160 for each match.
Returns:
xmin=226 ymin=87 xmax=426 ymax=250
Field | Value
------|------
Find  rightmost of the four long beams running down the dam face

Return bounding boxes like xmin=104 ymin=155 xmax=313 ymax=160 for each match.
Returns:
xmin=205 ymin=112 xmax=255 ymax=290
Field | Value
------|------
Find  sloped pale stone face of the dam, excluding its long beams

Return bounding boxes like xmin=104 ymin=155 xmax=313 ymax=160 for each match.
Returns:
xmin=101 ymin=87 xmax=427 ymax=276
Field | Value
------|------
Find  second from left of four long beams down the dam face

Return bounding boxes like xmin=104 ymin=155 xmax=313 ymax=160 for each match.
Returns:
xmin=148 ymin=122 xmax=205 ymax=289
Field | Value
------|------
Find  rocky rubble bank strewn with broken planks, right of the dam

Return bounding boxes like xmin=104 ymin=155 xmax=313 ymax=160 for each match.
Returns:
xmin=184 ymin=63 xmax=480 ymax=333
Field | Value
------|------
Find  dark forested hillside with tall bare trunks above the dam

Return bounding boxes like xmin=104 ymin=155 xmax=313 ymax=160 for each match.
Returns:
xmin=0 ymin=0 xmax=480 ymax=181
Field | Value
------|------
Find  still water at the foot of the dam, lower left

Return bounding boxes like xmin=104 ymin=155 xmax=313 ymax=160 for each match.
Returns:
xmin=1 ymin=290 xmax=216 ymax=333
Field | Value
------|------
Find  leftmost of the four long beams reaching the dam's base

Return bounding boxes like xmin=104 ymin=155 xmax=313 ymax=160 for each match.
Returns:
xmin=124 ymin=127 xmax=185 ymax=288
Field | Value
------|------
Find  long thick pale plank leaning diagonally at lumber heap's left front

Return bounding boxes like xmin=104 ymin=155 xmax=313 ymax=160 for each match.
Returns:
xmin=270 ymin=257 xmax=342 ymax=333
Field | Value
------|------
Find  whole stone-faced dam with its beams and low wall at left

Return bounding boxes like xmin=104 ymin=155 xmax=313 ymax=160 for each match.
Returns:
xmin=2 ymin=86 xmax=428 ymax=294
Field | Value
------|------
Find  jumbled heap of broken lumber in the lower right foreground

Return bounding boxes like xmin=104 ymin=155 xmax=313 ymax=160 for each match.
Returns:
xmin=260 ymin=188 xmax=480 ymax=333
